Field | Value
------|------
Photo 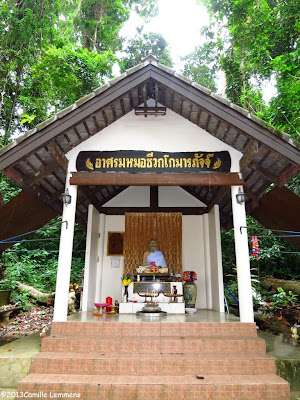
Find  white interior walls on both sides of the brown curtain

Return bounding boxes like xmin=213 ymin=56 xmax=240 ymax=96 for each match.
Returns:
xmin=83 ymin=206 xmax=224 ymax=312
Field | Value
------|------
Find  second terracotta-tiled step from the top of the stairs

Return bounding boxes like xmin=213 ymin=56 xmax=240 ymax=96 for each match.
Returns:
xmin=42 ymin=336 xmax=265 ymax=354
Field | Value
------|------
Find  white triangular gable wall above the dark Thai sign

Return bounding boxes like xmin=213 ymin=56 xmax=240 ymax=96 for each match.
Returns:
xmin=66 ymin=109 xmax=242 ymax=172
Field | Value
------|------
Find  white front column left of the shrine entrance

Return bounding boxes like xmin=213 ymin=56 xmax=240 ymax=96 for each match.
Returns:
xmin=53 ymin=178 xmax=77 ymax=322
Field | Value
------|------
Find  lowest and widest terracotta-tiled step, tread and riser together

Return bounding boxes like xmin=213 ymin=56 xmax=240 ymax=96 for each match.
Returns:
xmin=18 ymin=373 xmax=290 ymax=400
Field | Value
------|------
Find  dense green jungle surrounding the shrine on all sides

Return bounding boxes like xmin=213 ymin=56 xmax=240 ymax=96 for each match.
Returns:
xmin=0 ymin=0 xmax=300 ymax=340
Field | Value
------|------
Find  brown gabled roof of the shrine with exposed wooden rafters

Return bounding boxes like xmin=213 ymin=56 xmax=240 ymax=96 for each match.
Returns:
xmin=0 ymin=56 xmax=300 ymax=227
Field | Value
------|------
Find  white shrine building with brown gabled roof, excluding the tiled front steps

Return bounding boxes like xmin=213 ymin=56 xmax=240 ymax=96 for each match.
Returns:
xmin=0 ymin=56 xmax=300 ymax=322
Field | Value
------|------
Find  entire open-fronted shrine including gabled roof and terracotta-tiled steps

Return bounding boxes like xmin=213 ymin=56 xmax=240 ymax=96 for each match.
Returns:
xmin=0 ymin=56 xmax=300 ymax=400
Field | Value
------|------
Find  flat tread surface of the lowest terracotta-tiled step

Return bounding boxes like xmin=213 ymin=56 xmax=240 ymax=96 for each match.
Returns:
xmin=19 ymin=373 xmax=288 ymax=385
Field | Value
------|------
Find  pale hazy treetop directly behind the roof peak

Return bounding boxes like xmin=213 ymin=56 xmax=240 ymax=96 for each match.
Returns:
xmin=120 ymin=29 xmax=172 ymax=72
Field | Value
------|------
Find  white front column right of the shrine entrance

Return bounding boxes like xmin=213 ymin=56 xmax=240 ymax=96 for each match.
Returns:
xmin=231 ymin=186 xmax=254 ymax=322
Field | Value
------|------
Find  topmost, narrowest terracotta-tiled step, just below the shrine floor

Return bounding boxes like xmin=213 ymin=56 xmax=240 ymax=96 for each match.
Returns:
xmin=51 ymin=320 xmax=257 ymax=338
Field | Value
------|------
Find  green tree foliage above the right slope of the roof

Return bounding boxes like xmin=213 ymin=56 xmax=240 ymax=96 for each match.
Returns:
xmin=202 ymin=0 xmax=300 ymax=137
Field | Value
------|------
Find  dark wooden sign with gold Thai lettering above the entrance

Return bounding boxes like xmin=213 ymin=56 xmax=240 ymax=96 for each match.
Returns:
xmin=76 ymin=150 xmax=231 ymax=173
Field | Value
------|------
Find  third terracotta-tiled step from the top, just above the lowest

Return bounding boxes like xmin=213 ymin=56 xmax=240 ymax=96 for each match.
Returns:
xmin=30 ymin=352 xmax=276 ymax=376
